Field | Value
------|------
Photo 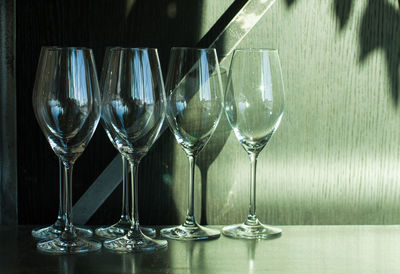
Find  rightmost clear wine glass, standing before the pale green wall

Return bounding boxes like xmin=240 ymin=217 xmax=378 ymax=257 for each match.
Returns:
xmin=222 ymin=49 xmax=284 ymax=239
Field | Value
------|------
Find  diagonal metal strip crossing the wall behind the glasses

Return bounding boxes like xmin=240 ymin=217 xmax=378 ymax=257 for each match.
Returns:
xmin=73 ymin=0 xmax=276 ymax=224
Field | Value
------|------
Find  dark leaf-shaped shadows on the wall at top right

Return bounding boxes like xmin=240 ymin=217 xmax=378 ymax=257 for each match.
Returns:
xmin=286 ymin=0 xmax=400 ymax=107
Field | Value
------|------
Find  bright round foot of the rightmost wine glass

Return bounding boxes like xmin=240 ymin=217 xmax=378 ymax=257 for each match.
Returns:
xmin=222 ymin=221 xmax=282 ymax=239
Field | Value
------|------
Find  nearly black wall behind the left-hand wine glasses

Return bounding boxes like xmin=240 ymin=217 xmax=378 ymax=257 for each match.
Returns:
xmin=16 ymin=0 xmax=202 ymax=224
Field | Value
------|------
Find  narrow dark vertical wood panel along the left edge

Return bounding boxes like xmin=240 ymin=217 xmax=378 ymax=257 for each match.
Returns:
xmin=0 ymin=0 xmax=18 ymax=224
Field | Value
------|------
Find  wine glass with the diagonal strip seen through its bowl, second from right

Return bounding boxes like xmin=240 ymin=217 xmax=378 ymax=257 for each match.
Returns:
xmin=161 ymin=48 xmax=223 ymax=240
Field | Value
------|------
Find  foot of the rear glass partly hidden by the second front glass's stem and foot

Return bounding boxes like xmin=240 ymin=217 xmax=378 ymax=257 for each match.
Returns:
xmin=94 ymin=220 xmax=156 ymax=239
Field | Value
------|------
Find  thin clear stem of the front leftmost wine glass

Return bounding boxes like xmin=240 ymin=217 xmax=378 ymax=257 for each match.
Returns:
xmin=62 ymin=163 xmax=76 ymax=240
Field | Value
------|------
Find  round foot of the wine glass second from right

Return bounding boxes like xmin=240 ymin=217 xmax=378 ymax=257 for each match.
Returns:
xmin=161 ymin=223 xmax=221 ymax=241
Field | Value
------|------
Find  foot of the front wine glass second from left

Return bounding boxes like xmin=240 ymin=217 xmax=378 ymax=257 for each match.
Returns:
xmin=103 ymin=230 xmax=168 ymax=252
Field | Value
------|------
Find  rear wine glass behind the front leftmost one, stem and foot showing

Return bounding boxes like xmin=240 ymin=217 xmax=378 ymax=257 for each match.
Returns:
xmin=32 ymin=159 xmax=93 ymax=240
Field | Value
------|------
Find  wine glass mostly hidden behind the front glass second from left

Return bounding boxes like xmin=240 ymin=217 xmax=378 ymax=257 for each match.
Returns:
xmin=95 ymin=47 xmax=156 ymax=239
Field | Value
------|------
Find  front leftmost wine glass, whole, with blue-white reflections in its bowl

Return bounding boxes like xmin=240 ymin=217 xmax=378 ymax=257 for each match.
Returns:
xmin=33 ymin=47 xmax=101 ymax=253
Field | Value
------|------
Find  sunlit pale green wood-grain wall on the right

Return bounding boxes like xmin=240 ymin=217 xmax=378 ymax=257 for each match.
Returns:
xmin=195 ymin=0 xmax=400 ymax=224
